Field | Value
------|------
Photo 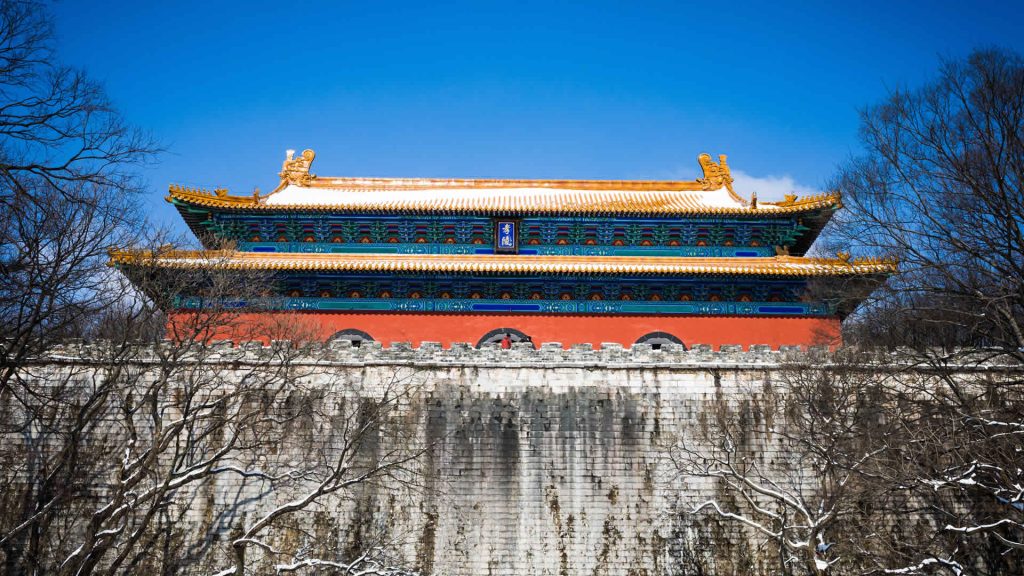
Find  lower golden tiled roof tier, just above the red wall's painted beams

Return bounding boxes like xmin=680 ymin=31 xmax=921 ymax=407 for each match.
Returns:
xmin=111 ymin=250 xmax=896 ymax=277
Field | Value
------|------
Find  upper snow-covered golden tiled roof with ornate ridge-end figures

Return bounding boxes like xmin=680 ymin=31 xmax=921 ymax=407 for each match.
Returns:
xmin=167 ymin=150 xmax=840 ymax=215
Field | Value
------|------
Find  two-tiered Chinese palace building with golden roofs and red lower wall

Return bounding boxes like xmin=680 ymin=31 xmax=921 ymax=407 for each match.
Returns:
xmin=114 ymin=150 xmax=895 ymax=346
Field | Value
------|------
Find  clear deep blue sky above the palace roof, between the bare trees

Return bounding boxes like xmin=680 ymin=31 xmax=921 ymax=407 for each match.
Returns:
xmin=54 ymin=0 xmax=1024 ymax=230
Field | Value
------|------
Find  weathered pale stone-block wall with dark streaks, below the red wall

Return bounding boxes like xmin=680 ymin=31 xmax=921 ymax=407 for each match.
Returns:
xmin=19 ymin=342 xmax=1019 ymax=576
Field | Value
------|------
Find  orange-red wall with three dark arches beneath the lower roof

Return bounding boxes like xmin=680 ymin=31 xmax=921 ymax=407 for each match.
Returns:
xmin=169 ymin=312 xmax=841 ymax=348
